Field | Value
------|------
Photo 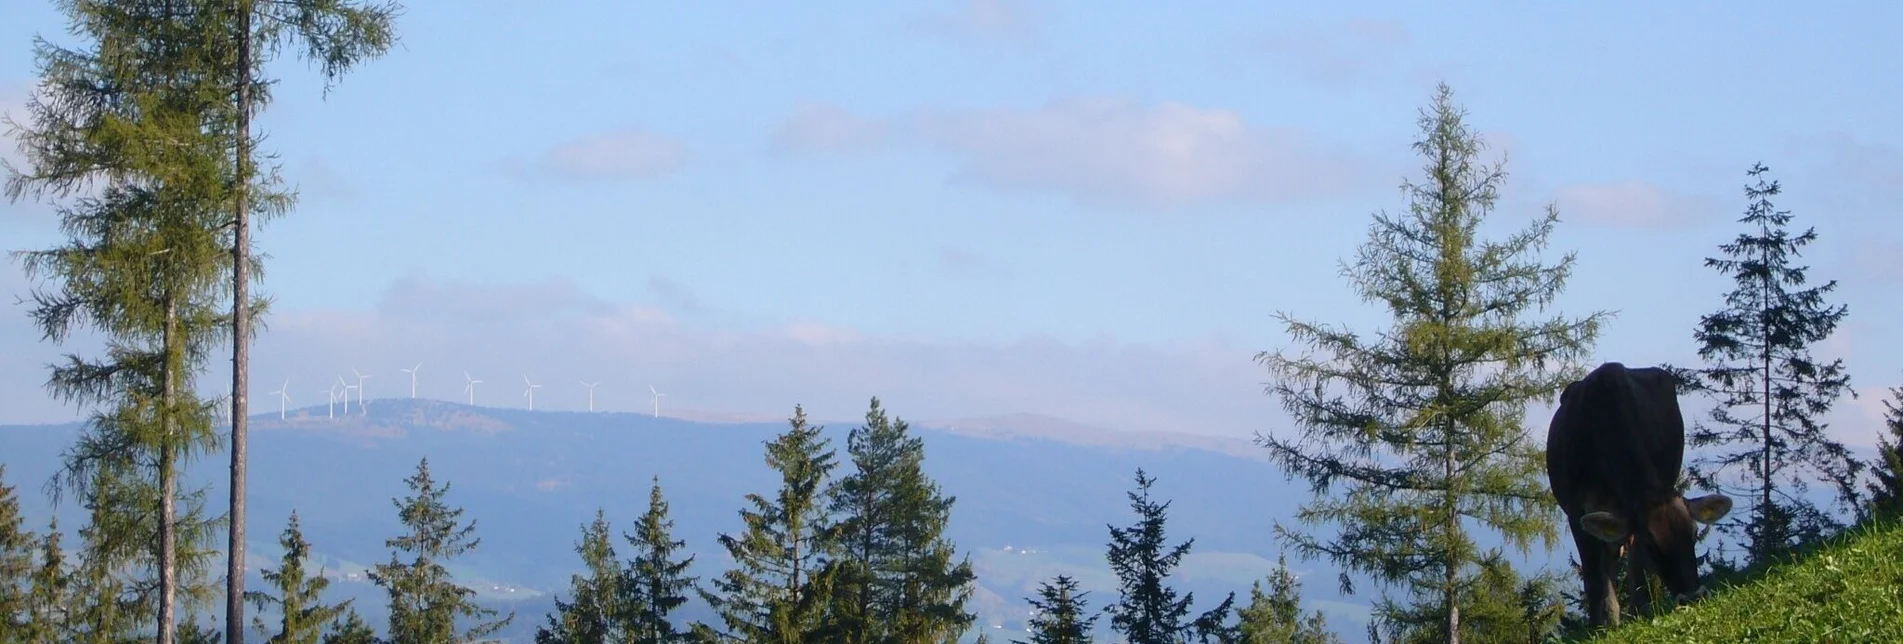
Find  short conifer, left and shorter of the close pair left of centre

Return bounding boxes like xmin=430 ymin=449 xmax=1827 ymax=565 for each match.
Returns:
xmin=535 ymin=509 xmax=632 ymax=644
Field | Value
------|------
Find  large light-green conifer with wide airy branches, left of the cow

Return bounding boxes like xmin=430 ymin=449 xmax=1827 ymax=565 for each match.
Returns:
xmin=1258 ymin=84 xmax=1604 ymax=642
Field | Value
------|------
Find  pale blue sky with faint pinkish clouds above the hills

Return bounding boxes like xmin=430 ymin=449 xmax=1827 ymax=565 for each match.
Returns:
xmin=0 ymin=0 xmax=1903 ymax=446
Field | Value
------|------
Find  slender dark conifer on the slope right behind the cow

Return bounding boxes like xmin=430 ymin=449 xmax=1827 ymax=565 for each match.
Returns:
xmin=1680 ymin=164 xmax=1865 ymax=562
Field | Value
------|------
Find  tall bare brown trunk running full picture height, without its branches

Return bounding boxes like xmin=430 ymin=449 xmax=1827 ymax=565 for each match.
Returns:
xmin=225 ymin=0 xmax=251 ymax=644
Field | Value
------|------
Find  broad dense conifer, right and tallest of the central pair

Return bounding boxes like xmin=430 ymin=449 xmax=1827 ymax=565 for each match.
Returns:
xmin=828 ymin=398 xmax=976 ymax=644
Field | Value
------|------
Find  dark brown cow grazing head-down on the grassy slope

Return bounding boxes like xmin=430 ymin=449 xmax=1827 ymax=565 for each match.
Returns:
xmin=1547 ymin=362 xmax=1732 ymax=627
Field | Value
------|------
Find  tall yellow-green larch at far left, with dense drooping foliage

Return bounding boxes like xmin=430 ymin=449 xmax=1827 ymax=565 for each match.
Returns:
xmin=6 ymin=0 xmax=241 ymax=644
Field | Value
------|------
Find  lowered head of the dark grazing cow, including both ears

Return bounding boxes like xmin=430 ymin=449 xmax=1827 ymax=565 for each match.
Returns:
xmin=1579 ymin=493 xmax=1732 ymax=602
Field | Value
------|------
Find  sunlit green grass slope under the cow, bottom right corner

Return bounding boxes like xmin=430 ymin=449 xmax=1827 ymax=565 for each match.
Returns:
xmin=1593 ymin=520 xmax=1903 ymax=642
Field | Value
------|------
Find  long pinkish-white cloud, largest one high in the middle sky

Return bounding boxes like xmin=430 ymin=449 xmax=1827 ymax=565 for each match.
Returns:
xmin=917 ymin=97 xmax=1383 ymax=208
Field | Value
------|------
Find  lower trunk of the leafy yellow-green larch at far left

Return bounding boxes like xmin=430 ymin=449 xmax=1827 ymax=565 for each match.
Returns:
xmin=158 ymin=293 xmax=183 ymax=644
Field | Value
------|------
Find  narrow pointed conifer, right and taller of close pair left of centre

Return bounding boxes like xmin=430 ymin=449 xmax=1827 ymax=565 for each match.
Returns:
xmin=622 ymin=476 xmax=698 ymax=644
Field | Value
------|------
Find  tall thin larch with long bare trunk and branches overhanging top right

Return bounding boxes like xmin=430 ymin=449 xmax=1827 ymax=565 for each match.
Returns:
xmin=200 ymin=0 xmax=400 ymax=644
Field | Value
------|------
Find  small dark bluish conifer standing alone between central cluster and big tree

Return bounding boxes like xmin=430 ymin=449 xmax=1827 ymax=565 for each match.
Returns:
xmin=1106 ymin=469 xmax=1235 ymax=644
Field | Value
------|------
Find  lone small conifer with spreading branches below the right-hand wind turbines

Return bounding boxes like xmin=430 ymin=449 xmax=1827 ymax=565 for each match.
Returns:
xmin=369 ymin=459 xmax=516 ymax=644
